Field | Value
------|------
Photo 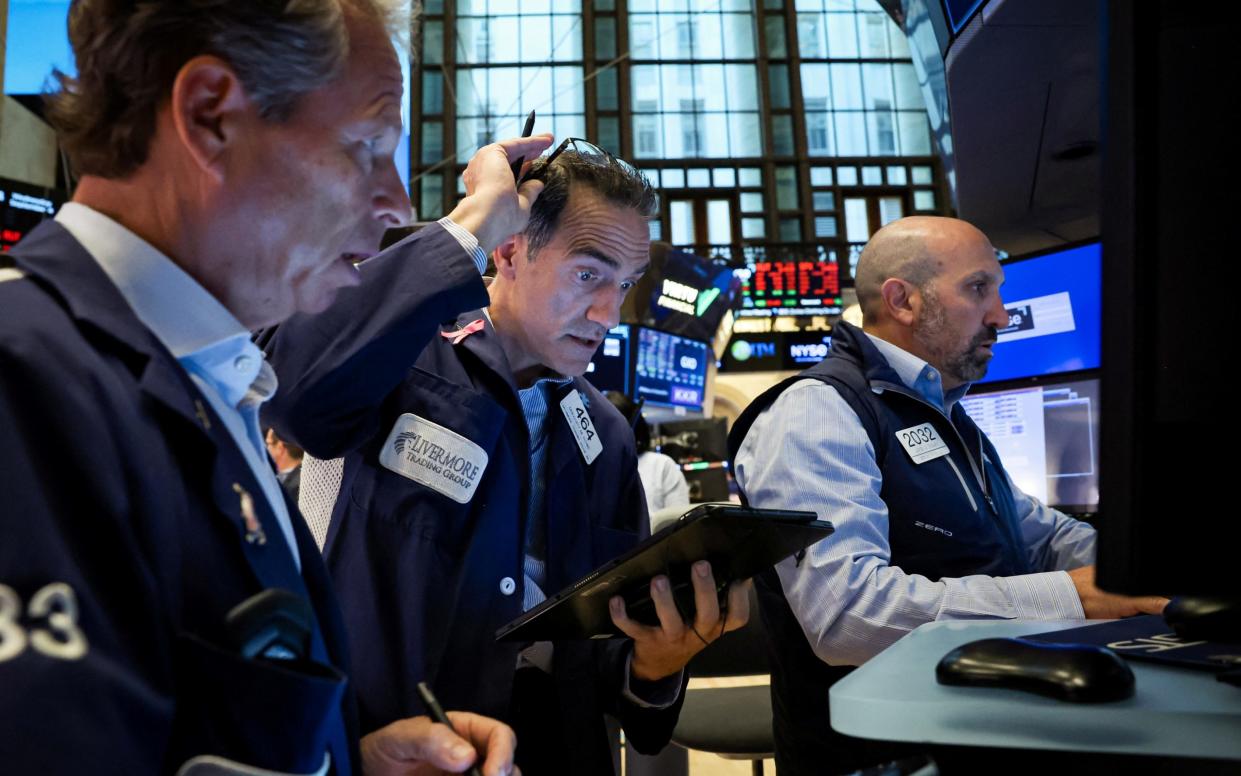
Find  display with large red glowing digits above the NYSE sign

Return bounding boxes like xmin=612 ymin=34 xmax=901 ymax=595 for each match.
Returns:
xmin=738 ymin=261 xmax=843 ymax=315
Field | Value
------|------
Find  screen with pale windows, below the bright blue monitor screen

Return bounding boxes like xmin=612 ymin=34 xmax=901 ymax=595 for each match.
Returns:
xmin=961 ymin=377 xmax=1100 ymax=514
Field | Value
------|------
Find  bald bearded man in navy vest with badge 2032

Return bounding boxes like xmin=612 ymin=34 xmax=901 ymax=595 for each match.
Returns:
xmin=730 ymin=216 xmax=1167 ymax=775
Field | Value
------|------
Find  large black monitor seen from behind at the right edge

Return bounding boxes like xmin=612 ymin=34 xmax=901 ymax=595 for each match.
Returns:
xmin=1097 ymin=0 xmax=1241 ymax=598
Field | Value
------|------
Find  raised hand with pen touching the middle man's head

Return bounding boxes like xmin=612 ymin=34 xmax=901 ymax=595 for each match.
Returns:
xmin=448 ymin=133 xmax=551 ymax=253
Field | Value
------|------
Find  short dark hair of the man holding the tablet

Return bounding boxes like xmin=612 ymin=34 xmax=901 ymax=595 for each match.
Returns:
xmin=525 ymin=150 xmax=659 ymax=259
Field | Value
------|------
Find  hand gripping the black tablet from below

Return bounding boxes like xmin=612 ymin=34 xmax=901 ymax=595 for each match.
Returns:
xmin=608 ymin=560 xmax=751 ymax=682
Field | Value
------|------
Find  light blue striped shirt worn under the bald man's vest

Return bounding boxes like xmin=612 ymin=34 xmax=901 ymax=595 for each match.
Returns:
xmin=736 ymin=334 xmax=1095 ymax=665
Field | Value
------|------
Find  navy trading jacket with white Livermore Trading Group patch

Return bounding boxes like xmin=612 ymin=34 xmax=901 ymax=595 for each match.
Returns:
xmin=271 ymin=240 xmax=680 ymax=774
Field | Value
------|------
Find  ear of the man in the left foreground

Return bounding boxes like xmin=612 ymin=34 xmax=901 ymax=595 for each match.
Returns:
xmin=170 ymin=56 xmax=257 ymax=181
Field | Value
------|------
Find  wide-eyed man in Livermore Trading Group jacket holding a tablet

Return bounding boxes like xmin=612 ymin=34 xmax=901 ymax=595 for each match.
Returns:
xmin=271 ymin=142 xmax=747 ymax=774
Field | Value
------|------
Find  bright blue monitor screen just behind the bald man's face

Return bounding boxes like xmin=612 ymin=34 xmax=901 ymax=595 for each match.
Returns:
xmin=983 ymin=242 xmax=1102 ymax=382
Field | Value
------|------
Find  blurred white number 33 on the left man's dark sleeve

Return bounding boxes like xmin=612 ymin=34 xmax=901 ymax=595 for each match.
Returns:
xmin=0 ymin=582 xmax=89 ymax=663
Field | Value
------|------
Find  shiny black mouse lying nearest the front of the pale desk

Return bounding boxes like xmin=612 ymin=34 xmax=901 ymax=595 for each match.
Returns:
xmin=934 ymin=638 xmax=1133 ymax=703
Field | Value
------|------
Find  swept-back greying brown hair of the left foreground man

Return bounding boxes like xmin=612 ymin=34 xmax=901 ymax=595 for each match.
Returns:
xmin=46 ymin=0 xmax=390 ymax=178
